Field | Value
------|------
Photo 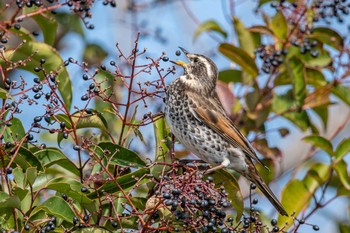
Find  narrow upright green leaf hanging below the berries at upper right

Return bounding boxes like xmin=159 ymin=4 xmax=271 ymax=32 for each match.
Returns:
xmin=285 ymin=58 xmax=306 ymax=107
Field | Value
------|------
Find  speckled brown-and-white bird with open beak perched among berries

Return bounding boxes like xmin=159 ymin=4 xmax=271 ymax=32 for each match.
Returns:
xmin=164 ymin=47 xmax=288 ymax=216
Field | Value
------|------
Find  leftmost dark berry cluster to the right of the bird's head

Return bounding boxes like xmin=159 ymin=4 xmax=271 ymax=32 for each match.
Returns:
xmin=254 ymin=45 xmax=287 ymax=73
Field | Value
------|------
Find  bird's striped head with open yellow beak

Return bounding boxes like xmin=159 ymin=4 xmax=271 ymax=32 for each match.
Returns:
xmin=172 ymin=47 xmax=218 ymax=91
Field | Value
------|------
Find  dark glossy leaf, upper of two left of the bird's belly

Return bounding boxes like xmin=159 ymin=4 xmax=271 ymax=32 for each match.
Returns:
xmin=91 ymin=142 xmax=147 ymax=168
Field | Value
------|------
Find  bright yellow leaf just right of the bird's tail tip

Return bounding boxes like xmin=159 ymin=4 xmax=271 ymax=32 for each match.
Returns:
xmin=278 ymin=180 xmax=312 ymax=228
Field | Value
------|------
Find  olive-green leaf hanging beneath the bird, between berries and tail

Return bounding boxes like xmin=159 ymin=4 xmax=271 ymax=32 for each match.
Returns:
xmin=212 ymin=169 xmax=244 ymax=221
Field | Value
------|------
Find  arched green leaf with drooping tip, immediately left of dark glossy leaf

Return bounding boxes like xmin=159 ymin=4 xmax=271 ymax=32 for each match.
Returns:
xmin=34 ymin=148 xmax=80 ymax=176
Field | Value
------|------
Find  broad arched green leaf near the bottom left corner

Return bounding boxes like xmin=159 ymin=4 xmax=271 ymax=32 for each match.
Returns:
xmin=31 ymin=196 xmax=75 ymax=223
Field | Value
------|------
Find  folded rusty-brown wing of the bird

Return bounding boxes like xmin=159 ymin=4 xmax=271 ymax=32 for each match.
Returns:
xmin=187 ymin=92 xmax=266 ymax=167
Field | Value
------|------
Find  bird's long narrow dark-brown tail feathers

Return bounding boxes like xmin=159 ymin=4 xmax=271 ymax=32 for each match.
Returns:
xmin=249 ymin=169 xmax=288 ymax=216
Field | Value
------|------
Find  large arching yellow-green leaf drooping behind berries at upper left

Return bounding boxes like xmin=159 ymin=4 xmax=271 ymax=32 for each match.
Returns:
xmin=5 ymin=41 xmax=72 ymax=109
